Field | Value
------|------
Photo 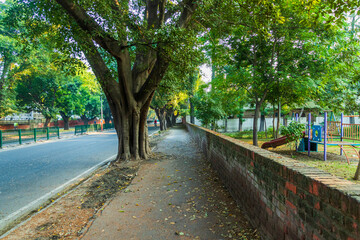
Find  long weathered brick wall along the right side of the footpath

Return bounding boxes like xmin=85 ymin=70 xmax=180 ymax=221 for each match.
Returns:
xmin=186 ymin=123 xmax=360 ymax=240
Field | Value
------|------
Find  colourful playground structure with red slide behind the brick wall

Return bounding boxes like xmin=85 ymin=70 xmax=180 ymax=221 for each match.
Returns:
xmin=261 ymin=112 xmax=360 ymax=179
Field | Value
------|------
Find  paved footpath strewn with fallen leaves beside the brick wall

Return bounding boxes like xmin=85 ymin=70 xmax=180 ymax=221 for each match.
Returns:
xmin=83 ymin=128 xmax=260 ymax=240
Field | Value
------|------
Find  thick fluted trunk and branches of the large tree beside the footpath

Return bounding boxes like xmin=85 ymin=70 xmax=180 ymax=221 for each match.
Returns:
xmin=56 ymin=0 xmax=197 ymax=160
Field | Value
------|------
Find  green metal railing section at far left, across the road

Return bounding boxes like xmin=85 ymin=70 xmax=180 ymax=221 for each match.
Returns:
xmin=0 ymin=127 xmax=60 ymax=148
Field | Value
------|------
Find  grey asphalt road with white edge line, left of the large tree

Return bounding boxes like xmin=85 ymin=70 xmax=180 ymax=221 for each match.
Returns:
xmin=0 ymin=128 xmax=158 ymax=229
